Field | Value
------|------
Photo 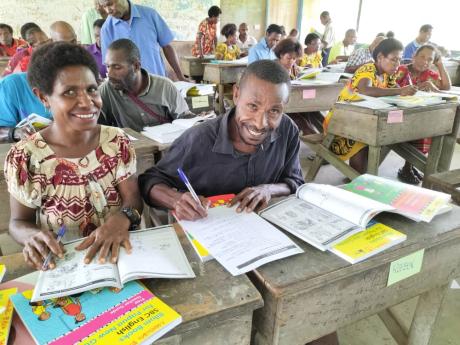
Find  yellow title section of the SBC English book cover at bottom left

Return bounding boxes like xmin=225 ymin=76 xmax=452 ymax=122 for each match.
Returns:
xmin=79 ymin=296 xmax=182 ymax=345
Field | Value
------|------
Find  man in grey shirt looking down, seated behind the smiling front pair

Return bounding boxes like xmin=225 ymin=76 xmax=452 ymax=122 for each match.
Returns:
xmin=100 ymin=38 xmax=191 ymax=131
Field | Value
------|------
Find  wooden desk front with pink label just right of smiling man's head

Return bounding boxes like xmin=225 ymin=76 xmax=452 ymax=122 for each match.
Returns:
xmin=284 ymin=82 xmax=343 ymax=113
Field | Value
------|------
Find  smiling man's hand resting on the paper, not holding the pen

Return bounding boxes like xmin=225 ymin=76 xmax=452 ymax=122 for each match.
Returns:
xmin=229 ymin=185 xmax=272 ymax=213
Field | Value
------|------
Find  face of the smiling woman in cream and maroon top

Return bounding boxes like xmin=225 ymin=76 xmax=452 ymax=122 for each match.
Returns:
xmin=44 ymin=66 xmax=102 ymax=131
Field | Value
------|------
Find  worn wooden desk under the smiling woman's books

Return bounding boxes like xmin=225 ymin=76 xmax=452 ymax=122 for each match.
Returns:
xmin=0 ymin=224 xmax=263 ymax=345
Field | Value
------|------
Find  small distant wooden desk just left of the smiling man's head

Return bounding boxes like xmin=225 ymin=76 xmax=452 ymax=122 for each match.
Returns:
xmin=203 ymin=63 xmax=247 ymax=114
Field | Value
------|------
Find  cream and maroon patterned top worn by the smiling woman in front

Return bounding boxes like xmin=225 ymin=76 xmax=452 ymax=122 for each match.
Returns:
xmin=5 ymin=126 xmax=136 ymax=242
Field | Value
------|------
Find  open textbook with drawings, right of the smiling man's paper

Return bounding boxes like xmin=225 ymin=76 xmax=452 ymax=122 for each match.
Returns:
xmin=260 ymin=175 xmax=450 ymax=250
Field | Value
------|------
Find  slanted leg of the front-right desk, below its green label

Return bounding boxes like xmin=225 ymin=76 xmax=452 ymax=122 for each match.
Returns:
xmin=407 ymin=285 xmax=448 ymax=345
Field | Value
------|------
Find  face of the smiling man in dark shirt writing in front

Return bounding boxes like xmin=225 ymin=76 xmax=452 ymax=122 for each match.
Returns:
xmin=233 ymin=76 xmax=289 ymax=146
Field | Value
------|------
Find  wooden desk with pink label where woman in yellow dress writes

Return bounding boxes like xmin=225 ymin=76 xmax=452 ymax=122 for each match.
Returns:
xmin=306 ymin=102 xmax=460 ymax=181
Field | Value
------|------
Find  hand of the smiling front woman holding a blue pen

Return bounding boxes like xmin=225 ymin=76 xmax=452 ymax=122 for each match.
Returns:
xmin=22 ymin=230 xmax=64 ymax=270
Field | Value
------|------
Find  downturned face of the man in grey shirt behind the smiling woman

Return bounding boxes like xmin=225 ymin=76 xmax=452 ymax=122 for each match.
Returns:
xmin=105 ymin=49 xmax=138 ymax=92
